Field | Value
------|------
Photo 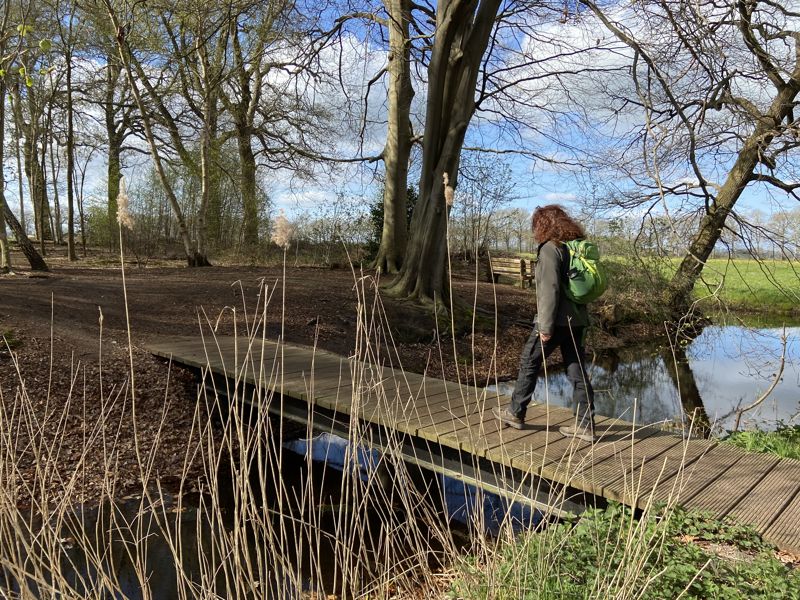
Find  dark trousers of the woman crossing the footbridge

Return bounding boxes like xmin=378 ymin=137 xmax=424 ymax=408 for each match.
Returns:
xmin=509 ymin=325 xmax=594 ymax=428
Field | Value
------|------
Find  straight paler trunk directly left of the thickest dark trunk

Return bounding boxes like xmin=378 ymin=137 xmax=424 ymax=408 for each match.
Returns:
xmin=375 ymin=0 xmax=414 ymax=274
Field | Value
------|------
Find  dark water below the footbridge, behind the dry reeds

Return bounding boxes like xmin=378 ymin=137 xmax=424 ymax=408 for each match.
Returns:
xmin=9 ymin=434 xmax=520 ymax=600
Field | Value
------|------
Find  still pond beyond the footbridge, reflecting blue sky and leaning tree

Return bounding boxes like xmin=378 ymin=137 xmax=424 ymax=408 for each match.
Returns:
xmin=498 ymin=325 xmax=800 ymax=432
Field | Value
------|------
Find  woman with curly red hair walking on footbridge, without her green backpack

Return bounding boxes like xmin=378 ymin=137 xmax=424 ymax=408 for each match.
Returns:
xmin=493 ymin=204 xmax=596 ymax=442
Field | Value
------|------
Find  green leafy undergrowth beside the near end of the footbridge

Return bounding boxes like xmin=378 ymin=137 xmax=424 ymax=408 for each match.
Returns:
xmin=452 ymin=504 xmax=800 ymax=600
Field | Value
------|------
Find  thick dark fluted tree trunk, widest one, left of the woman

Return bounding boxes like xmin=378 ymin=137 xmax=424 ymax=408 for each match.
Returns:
xmin=390 ymin=0 xmax=500 ymax=307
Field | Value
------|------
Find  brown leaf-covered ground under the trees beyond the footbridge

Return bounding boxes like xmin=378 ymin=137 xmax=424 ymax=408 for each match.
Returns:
xmin=0 ymin=250 xmax=652 ymax=506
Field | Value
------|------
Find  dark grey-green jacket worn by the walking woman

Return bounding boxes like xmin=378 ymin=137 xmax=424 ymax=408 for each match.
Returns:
xmin=535 ymin=242 xmax=589 ymax=335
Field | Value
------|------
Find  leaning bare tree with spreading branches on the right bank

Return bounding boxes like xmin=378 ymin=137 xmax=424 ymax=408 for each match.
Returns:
xmin=581 ymin=0 xmax=800 ymax=317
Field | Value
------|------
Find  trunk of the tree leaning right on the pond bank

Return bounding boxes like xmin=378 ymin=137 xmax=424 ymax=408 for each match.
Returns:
xmin=667 ymin=81 xmax=800 ymax=318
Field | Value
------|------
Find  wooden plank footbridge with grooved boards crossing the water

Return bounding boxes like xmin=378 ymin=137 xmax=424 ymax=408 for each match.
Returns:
xmin=148 ymin=338 xmax=800 ymax=553
